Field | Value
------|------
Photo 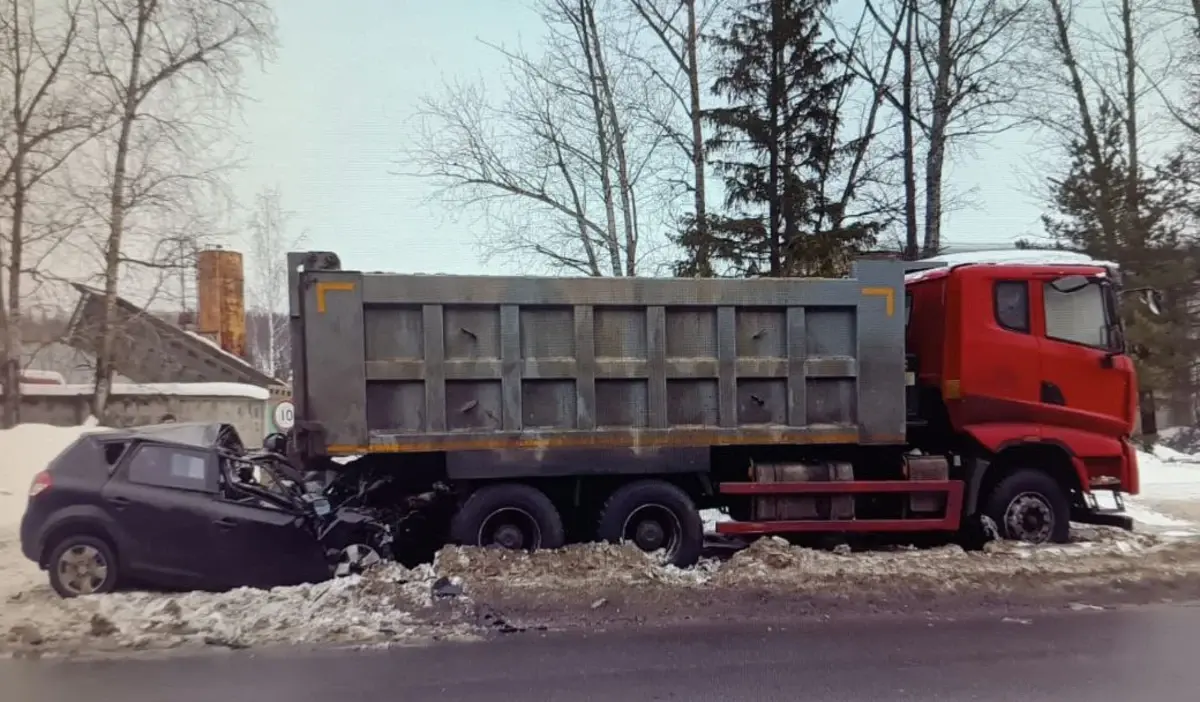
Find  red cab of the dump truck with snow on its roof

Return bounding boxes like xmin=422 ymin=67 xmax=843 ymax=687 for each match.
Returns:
xmin=905 ymin=252 xmax=1139 ymax=532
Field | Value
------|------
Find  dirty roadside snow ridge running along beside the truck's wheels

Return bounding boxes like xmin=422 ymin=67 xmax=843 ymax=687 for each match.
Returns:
xmin=436 ymin=524 xmax=1200 ymax=596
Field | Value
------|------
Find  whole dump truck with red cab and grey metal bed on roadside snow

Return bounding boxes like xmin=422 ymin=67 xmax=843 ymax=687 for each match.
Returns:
xmin=274 ymin=252 xmax=1156 ymax=565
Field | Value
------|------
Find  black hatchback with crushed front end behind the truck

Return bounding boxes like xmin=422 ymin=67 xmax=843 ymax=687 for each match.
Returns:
xmin=20 ymin=424 xmax=390 ymax=598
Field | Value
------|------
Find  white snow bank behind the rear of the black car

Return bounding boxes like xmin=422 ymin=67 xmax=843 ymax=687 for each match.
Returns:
xmin=0 ymin=420 xmax=106 ymax=528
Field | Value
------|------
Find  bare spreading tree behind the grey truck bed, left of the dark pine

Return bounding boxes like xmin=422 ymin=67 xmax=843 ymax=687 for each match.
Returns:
xmin=400 ymin=0 xmax=674 ymax=276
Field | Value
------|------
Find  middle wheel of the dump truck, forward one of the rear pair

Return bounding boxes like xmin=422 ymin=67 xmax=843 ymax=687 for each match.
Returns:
xmin=596 ymin=480 xmax=704 ymax=568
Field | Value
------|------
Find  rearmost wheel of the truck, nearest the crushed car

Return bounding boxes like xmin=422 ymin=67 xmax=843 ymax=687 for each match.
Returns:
xmin=450 ymin=482 xmax=566 ymax=551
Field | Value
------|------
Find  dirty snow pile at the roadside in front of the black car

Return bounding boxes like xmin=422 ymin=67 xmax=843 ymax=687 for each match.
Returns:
xmin=7 ymin=565 xmax=475 ymax=652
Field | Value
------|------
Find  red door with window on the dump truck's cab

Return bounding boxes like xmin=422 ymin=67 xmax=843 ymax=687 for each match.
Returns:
xmin=1030 ymin=276 xmax=1134 ymax=434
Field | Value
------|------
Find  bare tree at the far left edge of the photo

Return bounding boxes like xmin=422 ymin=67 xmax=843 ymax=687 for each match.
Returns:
xmin=0 ymin=0 xmax=96 ymax=426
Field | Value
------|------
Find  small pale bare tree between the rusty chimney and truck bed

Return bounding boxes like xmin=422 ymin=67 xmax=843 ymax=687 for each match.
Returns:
xmin=246 ymin=187 xmax=304 ymax=379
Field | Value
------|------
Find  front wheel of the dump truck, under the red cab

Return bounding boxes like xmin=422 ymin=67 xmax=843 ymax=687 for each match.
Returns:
xmin=984 ymin=468 xmax=1070 ymax=544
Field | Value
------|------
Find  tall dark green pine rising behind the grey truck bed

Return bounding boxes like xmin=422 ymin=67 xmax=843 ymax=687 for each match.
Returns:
xmin=678 ymin=0 xmax=875 ymax=276
